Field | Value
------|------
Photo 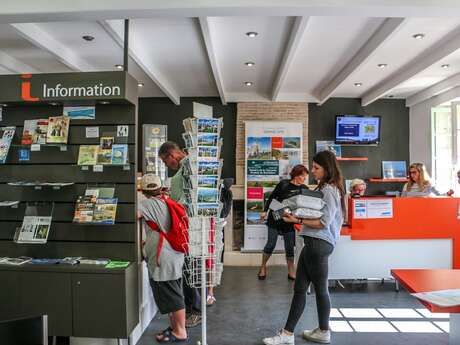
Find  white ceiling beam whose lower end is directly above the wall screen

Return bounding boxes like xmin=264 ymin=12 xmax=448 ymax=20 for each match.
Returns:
xmin=361 ymin=28 xmax=460 ymax=106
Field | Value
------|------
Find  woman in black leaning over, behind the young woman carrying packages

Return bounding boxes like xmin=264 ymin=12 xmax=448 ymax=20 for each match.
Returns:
xmin=258 ymin=164 xmax=308 ymax=280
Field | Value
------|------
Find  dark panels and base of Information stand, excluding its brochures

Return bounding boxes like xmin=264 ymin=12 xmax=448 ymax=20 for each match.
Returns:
xmin=0 ymin=71 xmax=140 ymax=339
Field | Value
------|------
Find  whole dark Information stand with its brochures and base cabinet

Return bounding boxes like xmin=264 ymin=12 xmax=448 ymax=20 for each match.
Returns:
xmin=0 ymin=71 xmax=140 ymax=339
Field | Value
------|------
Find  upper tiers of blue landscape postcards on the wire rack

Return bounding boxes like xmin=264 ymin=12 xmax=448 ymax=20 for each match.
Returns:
xmin=182 ymin=118 xmax=223 ymax=217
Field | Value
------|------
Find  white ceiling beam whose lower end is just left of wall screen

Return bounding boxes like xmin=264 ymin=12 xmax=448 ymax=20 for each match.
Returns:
xmin=319 ymin=18 xmax=405 ymax=105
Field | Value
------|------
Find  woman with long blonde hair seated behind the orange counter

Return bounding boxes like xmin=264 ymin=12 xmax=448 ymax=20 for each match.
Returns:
xmin=401 ymin=163 xmax=441 ymax=198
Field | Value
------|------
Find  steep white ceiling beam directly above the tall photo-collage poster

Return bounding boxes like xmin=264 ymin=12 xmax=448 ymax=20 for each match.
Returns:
xmin=272 ymin=17 xmax=309 ymax=102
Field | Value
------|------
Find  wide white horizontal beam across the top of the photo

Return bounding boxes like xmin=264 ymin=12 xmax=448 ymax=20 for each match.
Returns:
xmin=0 ymin=0 xmax=460 ymax=23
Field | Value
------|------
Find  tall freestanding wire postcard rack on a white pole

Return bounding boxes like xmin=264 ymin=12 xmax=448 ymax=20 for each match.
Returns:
xmin=182 ymin=118 xmax=224 ymax=345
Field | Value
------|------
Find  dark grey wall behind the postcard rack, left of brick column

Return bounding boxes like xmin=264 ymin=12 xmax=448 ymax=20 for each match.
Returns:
xmin=138 ymin=97 xmax=236 ymax=178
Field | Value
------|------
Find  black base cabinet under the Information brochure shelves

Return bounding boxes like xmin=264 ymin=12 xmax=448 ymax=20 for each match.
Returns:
xmin=0 ymin=264 xmax=139 ymax=338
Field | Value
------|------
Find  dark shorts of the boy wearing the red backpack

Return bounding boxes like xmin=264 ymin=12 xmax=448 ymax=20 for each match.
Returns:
xmin=150 ymin=278 xmax=185 ymax=314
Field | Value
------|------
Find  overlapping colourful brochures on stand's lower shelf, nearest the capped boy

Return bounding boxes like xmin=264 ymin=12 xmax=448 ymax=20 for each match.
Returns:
xmin=73 ymin=187 xmax=118 ymax=225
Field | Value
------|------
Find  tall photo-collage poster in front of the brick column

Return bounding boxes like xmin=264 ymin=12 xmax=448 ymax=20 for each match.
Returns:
xmin=242 ymin=121 xmax=303 ymax=251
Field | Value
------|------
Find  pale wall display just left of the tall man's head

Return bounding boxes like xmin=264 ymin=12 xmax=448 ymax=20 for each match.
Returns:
xmin=142 ymin=124 xmax=168 ymax=181
